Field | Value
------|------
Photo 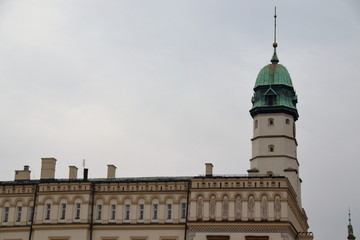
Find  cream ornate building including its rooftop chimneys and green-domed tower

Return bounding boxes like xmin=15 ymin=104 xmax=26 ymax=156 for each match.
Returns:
xmin=0 ymin=44 xmax=313 ymax=240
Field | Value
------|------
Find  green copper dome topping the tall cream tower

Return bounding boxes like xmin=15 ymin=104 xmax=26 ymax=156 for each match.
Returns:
xmin=250 ymin=47 xmax=299 ymax=121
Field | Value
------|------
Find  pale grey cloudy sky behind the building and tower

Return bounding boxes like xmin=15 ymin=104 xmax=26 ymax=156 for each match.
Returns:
xmin=0 ymin=0 xmax=360 ymax=239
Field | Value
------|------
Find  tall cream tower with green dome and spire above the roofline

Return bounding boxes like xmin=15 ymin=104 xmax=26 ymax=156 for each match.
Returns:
xmin=248 ymin=11 xmax=301 ymax=205
